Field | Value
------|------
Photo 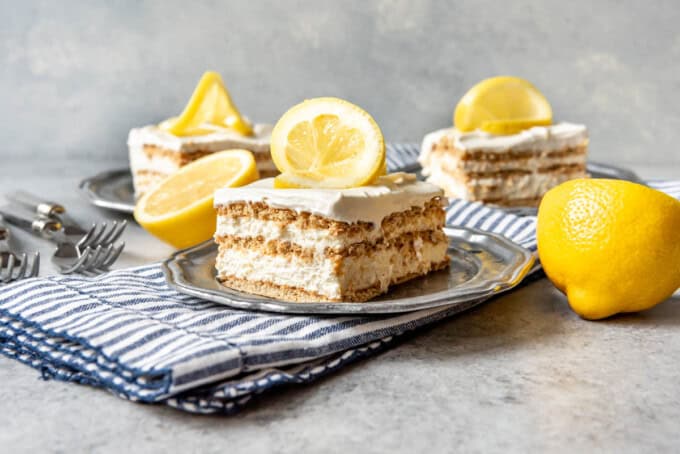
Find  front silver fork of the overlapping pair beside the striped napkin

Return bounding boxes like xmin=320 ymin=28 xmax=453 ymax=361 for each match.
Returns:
xmin=0 ymin=207 xmax=125 ymax=275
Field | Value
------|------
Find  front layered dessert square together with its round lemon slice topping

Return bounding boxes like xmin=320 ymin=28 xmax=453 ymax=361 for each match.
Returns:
xmin=210 ymin=98 xmax=449 ymax=302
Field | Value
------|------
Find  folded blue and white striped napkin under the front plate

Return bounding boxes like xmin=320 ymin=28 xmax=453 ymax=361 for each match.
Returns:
xmin=0 ymin=145 xmax=680 ymax=413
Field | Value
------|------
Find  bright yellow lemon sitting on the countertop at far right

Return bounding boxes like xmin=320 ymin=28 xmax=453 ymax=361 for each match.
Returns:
xmin=536 ymin=179 xmax=680 ymax=320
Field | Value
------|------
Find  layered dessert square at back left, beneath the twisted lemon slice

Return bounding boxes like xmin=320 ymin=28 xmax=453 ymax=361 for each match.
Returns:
xmin=128 ymin=124 xmax=278 ymax=197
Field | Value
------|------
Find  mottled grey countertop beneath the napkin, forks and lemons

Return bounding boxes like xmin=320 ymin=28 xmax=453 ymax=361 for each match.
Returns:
xmin=0 ymin=160 xmax=680 ymax=453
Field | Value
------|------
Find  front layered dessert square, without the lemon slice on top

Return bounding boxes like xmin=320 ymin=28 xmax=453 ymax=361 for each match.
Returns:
xmin=215 ymin=173 xmax=449 ymax=302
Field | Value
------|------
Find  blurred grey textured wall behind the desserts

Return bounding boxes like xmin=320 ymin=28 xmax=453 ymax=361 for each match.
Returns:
xmin=0 ymin=0 xmax=680 ymax=167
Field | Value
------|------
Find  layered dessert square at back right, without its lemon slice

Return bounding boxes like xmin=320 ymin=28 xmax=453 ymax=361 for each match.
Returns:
xmin=419 ymin=123 xmax=588 ymax=206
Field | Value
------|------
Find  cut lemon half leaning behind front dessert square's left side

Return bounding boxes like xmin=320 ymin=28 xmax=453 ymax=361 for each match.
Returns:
xmin=135 ymin=150 xmax=259 ymax=248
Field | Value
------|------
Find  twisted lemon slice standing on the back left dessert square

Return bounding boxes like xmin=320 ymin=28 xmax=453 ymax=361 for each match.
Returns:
xmin=158 ymin=71 xmax=253 ymax=136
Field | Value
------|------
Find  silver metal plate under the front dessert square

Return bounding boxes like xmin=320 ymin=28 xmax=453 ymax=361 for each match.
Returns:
xmin=162 ymin=227 xmax=534 ymax=314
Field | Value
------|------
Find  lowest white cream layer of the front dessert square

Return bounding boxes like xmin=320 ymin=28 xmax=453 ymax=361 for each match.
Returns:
xmin=215 ymin=241 xmax=448 ymax=299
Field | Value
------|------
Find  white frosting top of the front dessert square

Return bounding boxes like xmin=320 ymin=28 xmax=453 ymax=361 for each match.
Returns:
xmin=215 ymin=172 xmax=446 ymax=226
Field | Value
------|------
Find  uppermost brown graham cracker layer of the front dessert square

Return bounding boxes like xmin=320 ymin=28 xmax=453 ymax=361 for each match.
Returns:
xmin=217 ymin=197 xmax=445 ymax=238
